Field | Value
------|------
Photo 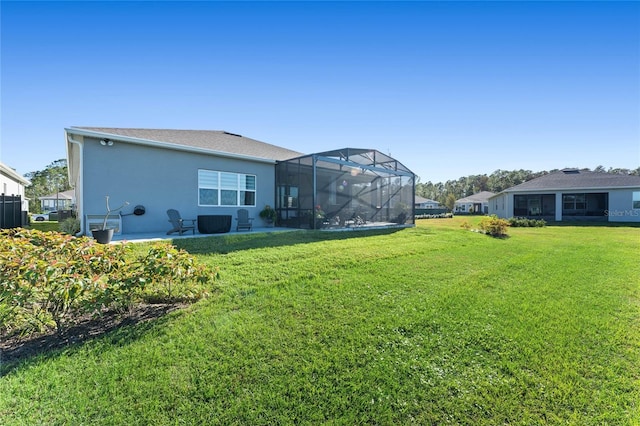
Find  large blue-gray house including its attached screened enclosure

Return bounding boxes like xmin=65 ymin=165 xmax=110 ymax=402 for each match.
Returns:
xmin=65 ymin=127 xmax=415 ymax=234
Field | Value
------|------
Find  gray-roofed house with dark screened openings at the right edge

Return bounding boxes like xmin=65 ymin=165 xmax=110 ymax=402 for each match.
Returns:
xmin=489 ymin=169 xmax=640 ymax=222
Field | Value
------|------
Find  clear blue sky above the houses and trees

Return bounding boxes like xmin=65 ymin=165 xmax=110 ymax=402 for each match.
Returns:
xmin=0 ymin=1 xmax=640 ymax=182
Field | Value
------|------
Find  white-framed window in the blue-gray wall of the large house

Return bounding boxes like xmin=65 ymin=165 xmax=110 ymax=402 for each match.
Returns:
xmin=198 ymin=170 xmax=256 ymax=206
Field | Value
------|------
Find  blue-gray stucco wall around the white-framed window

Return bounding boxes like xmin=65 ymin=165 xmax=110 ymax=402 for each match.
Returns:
xmin=79 ymin=137 xmax=275 ymax=234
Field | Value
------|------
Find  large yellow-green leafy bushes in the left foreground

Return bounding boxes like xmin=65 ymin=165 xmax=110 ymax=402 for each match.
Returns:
xmin=0 ymin=228 xmax=218 ymax=335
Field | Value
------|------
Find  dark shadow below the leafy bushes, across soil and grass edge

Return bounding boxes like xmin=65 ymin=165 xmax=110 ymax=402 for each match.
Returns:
xmin=0 ymin=303 xmax=187 ymax=377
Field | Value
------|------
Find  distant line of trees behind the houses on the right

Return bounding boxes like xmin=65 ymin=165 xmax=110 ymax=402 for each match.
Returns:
xmin=416 ymin=166 xmax=640 ymax=209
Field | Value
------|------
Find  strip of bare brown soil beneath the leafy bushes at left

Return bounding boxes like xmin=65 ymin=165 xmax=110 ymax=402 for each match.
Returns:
xmin=0 ymin=303 xmax=187 ymax=363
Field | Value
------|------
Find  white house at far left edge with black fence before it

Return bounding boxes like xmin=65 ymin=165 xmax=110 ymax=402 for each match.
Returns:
xmin=0 ymin=163 xmax=31 ymax=228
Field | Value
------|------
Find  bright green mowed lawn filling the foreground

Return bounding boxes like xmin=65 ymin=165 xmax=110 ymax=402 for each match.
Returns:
xmin=0 ymin=219 xmax=640 ymax=425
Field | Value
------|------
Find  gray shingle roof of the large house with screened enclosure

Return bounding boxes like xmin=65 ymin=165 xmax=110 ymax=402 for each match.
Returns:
xmin=68 ymin=126 xmax=303 ymax=160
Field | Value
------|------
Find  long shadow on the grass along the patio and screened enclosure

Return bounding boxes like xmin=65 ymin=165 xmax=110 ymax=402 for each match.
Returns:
xmin=172 ymin=228 xmax=406 ymax=254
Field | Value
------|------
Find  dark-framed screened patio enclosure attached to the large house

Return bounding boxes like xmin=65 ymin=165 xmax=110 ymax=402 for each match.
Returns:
xmin=276 ymin=148 xmax=415 ymax=229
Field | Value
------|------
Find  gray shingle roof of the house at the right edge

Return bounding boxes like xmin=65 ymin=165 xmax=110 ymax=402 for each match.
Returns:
xmin=503 ymin=169 xmax=640 ymax=192
